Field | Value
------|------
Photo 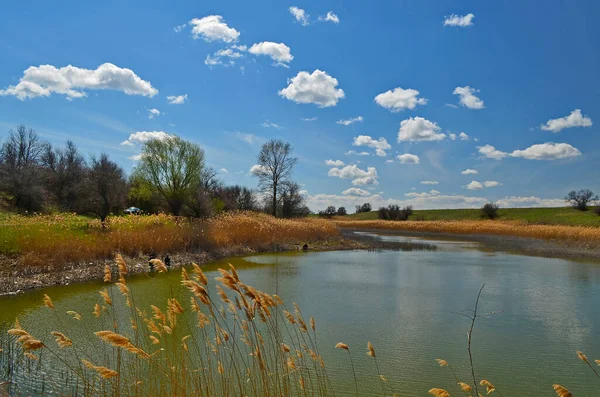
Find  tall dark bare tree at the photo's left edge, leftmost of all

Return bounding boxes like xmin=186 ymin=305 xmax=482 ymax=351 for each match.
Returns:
xmin=0 ymin=125 xmax=46 ymax=211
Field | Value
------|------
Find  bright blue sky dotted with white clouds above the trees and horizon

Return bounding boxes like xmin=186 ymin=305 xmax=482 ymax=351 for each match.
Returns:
xmin=0 ymin=0 xmax=600 ymax=210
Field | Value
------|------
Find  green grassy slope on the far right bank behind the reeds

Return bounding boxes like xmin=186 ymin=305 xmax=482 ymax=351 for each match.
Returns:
xmin=344 ymin=207 xmax=600 ymax=227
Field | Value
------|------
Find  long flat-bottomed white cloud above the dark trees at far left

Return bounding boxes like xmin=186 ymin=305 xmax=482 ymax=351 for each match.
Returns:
xmin=0 ymin=63 xmax=158 ymax=101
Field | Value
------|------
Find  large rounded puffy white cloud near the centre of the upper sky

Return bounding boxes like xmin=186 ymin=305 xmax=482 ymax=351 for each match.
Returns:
xmin=279 ymin=69 xmax=344 ymax=107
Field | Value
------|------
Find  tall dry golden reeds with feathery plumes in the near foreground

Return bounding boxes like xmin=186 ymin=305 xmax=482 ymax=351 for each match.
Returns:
xmin=0 ymin=256 xmax=600 ymax=397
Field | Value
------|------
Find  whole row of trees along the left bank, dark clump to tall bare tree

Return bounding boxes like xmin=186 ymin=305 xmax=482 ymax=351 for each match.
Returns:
xmin=0 ymin=126 xmax=310 ymax=221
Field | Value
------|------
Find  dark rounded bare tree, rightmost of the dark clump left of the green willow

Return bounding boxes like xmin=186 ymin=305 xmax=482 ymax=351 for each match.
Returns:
xmin=85 ymin=153 xmax=128 ymax=223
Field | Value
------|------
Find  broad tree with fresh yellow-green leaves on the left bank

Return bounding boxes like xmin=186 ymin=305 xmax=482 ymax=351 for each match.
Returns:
xmin=134 ymin=136 xmax=204 ymax=215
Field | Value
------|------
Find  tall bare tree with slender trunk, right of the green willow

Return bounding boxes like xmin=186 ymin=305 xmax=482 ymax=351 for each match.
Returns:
xmin=253 ymin=139 xmax=298 ymax=216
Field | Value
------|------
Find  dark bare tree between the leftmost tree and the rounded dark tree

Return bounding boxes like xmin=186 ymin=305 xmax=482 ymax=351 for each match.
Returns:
xmin=41 ymin=141 xmax=86 ymax=211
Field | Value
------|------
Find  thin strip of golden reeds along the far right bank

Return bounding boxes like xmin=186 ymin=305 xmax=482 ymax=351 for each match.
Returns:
xmin=333 ymin=220 xmax=600 ymax=244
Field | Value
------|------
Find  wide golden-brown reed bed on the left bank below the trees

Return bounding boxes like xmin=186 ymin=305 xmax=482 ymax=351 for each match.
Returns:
xmin=0 ymin=212 xmax=338 ymax=271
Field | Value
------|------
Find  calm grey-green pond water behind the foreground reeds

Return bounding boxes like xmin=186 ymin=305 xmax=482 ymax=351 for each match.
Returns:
xmin=0 ymin=230 xmax=600 ymax=397
